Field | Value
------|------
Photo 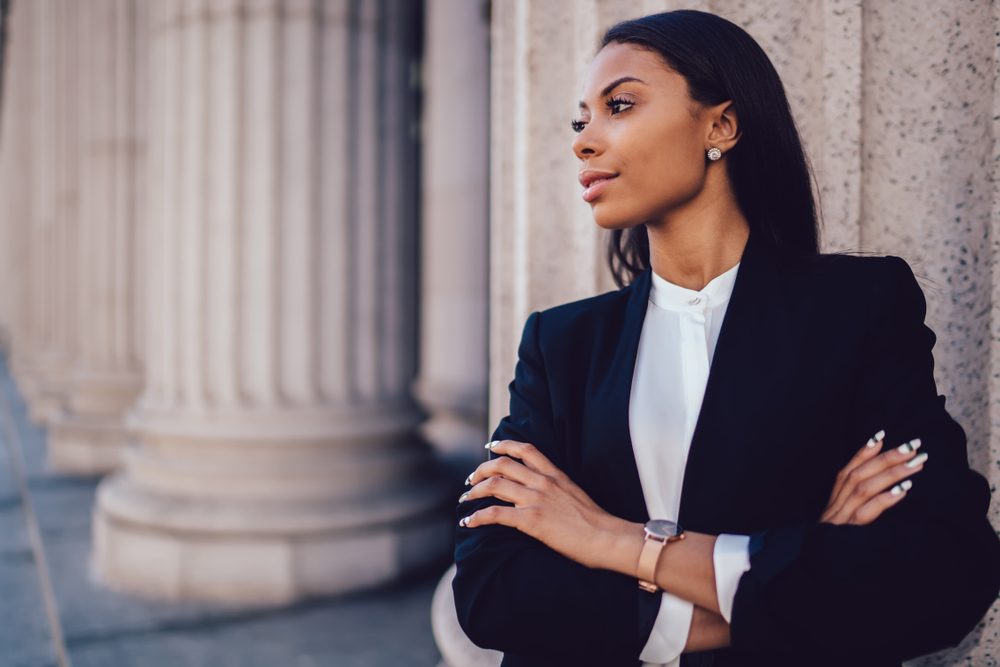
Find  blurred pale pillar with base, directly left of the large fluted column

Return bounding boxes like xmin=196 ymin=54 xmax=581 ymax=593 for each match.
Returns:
xmin=49 ymin=0 xmax=148 ymax=474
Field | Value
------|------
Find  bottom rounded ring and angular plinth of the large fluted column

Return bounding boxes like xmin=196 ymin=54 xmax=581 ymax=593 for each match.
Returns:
xmin=91 ymin=473 xmax=456 ymax=605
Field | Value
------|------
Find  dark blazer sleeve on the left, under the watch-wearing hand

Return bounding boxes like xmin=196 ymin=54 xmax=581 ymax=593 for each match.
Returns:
xmin=452 ymin=312 xmax=646 ymax=665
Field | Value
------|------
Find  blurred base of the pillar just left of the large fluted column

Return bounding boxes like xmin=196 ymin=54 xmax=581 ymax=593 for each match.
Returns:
xmin=48 ymin=412 xmax=128 ymax=476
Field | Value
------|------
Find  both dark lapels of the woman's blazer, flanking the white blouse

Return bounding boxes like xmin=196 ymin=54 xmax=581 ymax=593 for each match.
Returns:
xmin=584 ymin=228 xmax=798 ymax=532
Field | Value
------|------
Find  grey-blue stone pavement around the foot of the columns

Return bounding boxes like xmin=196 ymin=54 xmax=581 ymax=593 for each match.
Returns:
xmin=0 ymin=365 xmax=461 ymax=667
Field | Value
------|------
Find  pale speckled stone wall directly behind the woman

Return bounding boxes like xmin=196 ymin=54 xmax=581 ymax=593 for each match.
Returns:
xmin=490 ymin=0 xmax=1000 ymax=667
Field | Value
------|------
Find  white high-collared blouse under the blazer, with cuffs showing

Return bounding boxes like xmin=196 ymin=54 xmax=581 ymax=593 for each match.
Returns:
xmin=629 ymin=263 xmax=750 ymax=667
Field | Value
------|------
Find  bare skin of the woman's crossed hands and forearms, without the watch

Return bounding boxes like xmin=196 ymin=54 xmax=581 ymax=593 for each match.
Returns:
xmin=460 ymin=431 xmax=927 ymax=652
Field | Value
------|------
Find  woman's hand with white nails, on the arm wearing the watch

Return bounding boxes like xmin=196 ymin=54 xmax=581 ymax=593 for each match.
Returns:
xmin=459 ymin=440 xmax=624 ymax=567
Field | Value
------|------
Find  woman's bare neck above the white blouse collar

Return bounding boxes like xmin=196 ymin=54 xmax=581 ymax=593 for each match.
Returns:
xmin=646 ymin=183 xmax=750 ymax=290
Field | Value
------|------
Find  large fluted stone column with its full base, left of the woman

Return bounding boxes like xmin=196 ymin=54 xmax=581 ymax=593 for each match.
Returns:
xmin=93 ymin=0 xmax=454 ymax=603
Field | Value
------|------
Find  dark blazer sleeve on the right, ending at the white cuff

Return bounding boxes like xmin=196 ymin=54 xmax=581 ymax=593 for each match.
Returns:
xmin=730 ymin=256 xmax=1000 ymax=664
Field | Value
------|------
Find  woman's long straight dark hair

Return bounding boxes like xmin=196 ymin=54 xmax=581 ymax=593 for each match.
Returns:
xmin=601 ymin=9 xmax=819 ymax=287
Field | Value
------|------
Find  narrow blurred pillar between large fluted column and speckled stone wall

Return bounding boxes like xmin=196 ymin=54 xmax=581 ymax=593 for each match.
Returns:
xmin=414 ymin=0 xmax=490 ymax=462
